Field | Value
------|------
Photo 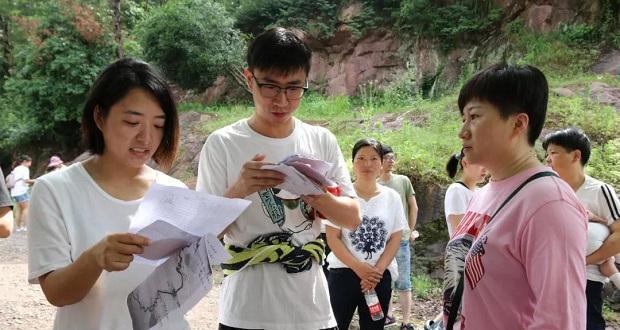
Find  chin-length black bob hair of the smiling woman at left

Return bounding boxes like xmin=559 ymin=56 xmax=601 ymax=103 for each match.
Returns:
xmin=82 ymin=58 xmax=179 ymax=169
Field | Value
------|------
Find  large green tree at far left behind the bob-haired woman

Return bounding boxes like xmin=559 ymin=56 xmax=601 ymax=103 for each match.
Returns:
xmin=0 ymin=1 xmax=114 ymax=148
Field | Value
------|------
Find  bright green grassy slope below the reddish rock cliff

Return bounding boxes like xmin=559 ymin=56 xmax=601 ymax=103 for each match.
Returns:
xmin=174 ymin=74 xmax=620 ymax=190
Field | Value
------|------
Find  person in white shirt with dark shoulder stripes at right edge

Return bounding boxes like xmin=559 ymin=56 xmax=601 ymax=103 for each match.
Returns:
xmin=543 ymin=127 xmax=620 ymax=330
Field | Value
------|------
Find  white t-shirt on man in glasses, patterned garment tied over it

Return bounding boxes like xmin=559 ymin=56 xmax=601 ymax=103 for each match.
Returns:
xmin=196 ymin=119 xmax=355 ymax=330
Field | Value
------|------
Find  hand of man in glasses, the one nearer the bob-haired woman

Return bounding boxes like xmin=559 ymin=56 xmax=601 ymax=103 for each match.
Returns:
xmin=224 ymin=154 xmax=285 ymax=198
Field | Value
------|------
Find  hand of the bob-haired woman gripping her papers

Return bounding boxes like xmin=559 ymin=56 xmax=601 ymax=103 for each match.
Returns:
xmin=90 ymin=233 xmax=151 ymax=272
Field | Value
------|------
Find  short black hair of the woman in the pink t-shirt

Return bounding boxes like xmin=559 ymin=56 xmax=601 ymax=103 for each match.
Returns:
xmin=458 ymin=63 xmax=549 ymax=146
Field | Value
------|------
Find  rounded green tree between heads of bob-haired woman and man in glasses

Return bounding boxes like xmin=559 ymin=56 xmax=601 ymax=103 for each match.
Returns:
xmin=138 ymin=0 xmax=243 ymax=90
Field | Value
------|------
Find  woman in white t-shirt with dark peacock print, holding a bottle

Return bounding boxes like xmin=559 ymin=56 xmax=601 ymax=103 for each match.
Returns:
xmin=326 ymin=139 xmax=406 ymax=329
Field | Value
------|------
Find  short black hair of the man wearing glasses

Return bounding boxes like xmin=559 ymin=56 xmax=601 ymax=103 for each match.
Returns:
xmin=247 ymin=27 xmax=312 ymax=75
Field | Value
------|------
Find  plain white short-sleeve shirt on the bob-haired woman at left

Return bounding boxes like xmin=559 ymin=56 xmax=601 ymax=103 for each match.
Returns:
xmin=28 ymin=163 xmax=189 ymax=330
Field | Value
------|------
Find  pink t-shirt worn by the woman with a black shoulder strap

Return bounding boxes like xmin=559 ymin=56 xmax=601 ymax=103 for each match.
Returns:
xmin=447 ymin=166 xmax=587 ymax=330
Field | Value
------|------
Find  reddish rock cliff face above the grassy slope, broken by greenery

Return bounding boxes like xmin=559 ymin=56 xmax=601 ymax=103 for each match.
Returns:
xmin=192 ymin=0 xmax=620 ymax=103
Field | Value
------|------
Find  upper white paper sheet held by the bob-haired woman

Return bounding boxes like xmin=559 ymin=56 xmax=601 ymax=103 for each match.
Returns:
xmin=129 ymin=183 xmax=251 ymax=264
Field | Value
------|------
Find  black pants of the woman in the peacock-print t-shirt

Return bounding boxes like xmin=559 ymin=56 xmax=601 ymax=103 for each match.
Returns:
xmin=327 ymin=268 xmax=392 ymax=330
